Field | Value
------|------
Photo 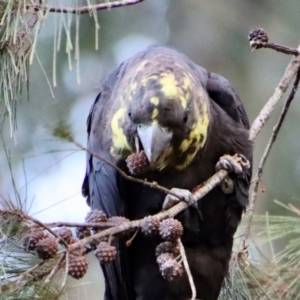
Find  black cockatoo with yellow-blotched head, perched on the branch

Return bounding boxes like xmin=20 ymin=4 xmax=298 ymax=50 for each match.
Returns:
xmin=83 ymin=46 xmax=252 ymax=300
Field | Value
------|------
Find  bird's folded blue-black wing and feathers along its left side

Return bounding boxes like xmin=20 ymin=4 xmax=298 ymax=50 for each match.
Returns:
xmin=82 ymin=65 xmax=133 ymax=300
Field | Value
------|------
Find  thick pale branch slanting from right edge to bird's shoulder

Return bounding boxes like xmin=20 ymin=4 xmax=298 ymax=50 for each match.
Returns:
xmin=249 ymin=46 xmax=300 ymax=141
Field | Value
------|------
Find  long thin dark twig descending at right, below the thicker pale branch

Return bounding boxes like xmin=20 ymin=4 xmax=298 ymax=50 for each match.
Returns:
xmin=242 ymin=62 xmax=300 ymax=247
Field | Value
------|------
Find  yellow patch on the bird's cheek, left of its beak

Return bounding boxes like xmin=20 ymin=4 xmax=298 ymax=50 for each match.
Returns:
xmin=110 ymin=107 xmax=131 ymax=155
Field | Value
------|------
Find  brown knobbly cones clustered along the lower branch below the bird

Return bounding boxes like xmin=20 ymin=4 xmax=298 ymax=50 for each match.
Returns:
xmin=23 ymin=210 xmax=183 ymax=281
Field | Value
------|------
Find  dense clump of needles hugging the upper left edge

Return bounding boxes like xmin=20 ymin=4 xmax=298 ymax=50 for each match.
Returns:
xmin=0 ymin=0 xmax=39 ymax=133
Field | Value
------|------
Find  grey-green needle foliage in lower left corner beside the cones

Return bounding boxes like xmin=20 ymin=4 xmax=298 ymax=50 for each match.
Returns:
xmin=0 ymin=210 xmax=62 ymax=300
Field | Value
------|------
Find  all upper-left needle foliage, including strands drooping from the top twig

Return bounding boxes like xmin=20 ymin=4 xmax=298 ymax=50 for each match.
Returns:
xmin=0 ymin=0 xmax=105 ymax=135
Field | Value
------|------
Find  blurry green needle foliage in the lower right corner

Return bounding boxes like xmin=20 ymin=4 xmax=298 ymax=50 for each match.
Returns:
xmin=220 ymin=202 xmax=300 ymax=300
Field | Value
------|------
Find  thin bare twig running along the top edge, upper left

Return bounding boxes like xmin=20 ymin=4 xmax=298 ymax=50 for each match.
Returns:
xmin=26 ymin=0 xmax=144 ymax=15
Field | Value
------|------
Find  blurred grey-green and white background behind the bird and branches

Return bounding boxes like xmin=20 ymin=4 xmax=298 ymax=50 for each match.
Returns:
xmin=0 ymin=0 xmax=300 ymax=299
